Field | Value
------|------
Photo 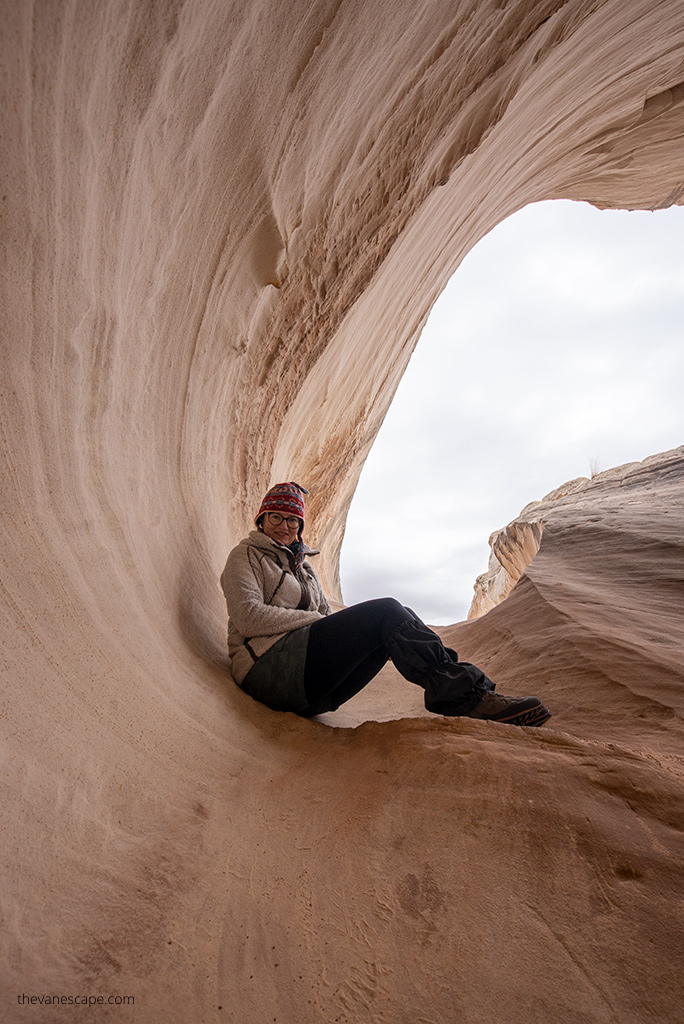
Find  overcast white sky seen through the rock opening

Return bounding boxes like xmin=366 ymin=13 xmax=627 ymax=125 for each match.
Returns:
xmin=341 ymin=195 xmax=684 ymax=624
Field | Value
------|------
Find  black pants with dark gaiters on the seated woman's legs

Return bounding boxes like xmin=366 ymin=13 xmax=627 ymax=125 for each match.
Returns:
xmin=301 ymin=597 xmax=494 ymax=716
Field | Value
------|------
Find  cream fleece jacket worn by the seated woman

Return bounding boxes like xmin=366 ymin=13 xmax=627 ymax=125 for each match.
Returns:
xmin=221 ymin=529 xmax=332 ymax=683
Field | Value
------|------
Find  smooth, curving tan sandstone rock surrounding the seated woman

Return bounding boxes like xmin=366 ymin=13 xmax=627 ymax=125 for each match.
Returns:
xmin=0 ymin=0 xmax=684 ymax=1024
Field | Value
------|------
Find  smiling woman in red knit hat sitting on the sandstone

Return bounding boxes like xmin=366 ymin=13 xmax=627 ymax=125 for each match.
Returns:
xmin=221 ymin=482 xmax=551 ymax=725
